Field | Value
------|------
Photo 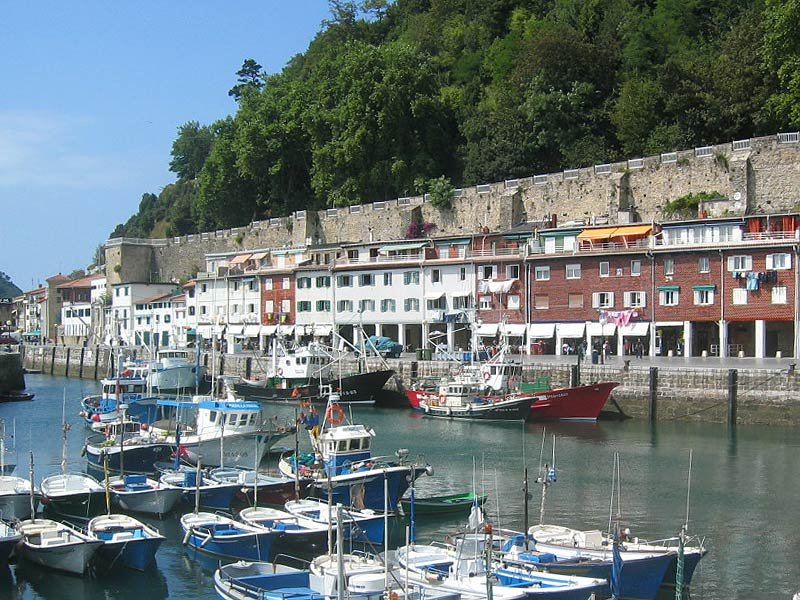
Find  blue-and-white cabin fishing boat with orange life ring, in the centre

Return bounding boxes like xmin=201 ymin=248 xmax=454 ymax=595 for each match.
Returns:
xmin=278 ymin=393 xmax=433 ymax=511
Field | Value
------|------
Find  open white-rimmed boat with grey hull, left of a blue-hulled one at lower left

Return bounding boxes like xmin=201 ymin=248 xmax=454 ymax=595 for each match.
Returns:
xmin=17 ymin=519 xmax=103 ymax=575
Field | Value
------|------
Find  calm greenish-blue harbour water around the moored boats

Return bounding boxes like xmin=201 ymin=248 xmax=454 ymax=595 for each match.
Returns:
xmin=0 ymin=375 xmax=800 ymax=599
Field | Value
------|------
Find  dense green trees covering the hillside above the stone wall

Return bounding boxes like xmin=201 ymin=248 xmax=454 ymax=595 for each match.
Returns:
xmin=113 ymin=0 xmax=800 ymax=236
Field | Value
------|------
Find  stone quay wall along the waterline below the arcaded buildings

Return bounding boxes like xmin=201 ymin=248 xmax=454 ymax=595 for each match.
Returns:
xmin=20 ymin=346 xmax=800 ymax=426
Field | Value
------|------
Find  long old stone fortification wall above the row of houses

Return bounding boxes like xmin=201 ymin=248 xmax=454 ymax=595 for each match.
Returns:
xmin=106 ymin=133 xmax=800 ymax=283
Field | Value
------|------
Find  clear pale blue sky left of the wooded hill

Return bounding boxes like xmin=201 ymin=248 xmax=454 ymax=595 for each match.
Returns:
xmin=0 ymin=0 xmax=329 ymax=290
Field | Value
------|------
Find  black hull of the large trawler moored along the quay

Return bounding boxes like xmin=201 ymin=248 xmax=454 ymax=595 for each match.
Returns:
xmin=234 ymin=369 xmax=394 ymax=404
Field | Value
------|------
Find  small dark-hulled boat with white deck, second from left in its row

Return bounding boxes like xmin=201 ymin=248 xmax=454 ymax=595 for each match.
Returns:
xmin=40 ymin=473 xmax=105 ymax=519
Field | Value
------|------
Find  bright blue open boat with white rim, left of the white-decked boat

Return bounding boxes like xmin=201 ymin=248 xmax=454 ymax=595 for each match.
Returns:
xmin=181 ymin=512 xmax=280 ymax=561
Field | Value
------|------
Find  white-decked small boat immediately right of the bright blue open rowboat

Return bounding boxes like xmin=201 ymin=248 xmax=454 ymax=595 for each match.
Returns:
xmin=237 ymin=506 xmax=329 ymax=555
